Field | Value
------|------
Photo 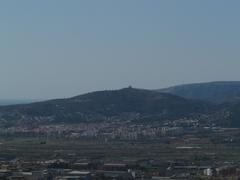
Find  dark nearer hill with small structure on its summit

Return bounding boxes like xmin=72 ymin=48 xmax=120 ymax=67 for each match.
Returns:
xmin=0 ymin=88 xmax=210 ymax=126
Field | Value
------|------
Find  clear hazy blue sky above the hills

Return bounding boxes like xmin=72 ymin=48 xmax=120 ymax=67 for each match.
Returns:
xmin=0 ymin=0 xmax=240 ymax=99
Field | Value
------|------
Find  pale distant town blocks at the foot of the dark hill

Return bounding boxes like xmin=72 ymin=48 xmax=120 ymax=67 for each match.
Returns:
xmin=0 ymin=123 xmax=184 ymax=140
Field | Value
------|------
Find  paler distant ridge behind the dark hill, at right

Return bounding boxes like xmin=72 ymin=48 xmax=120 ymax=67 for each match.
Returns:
xmin=157 ymin=81 xmax=240 ymax=104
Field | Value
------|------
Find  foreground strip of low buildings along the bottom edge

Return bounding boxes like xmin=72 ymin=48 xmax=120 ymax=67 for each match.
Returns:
xmin=0 ymin=159 xmax=240 ymax=180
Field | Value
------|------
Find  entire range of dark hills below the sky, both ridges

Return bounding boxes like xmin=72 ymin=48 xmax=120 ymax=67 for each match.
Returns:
xmin=0 ymin=82 xmax=240 ymax=127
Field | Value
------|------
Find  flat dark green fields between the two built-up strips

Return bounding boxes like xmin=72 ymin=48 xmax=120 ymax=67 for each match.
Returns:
xmin=0 ymin=138 xmax=240 ymax=163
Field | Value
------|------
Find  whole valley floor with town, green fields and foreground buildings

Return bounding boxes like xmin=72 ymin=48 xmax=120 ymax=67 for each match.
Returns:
xmin=0 ymin=118 xmax=240 ymax=180
